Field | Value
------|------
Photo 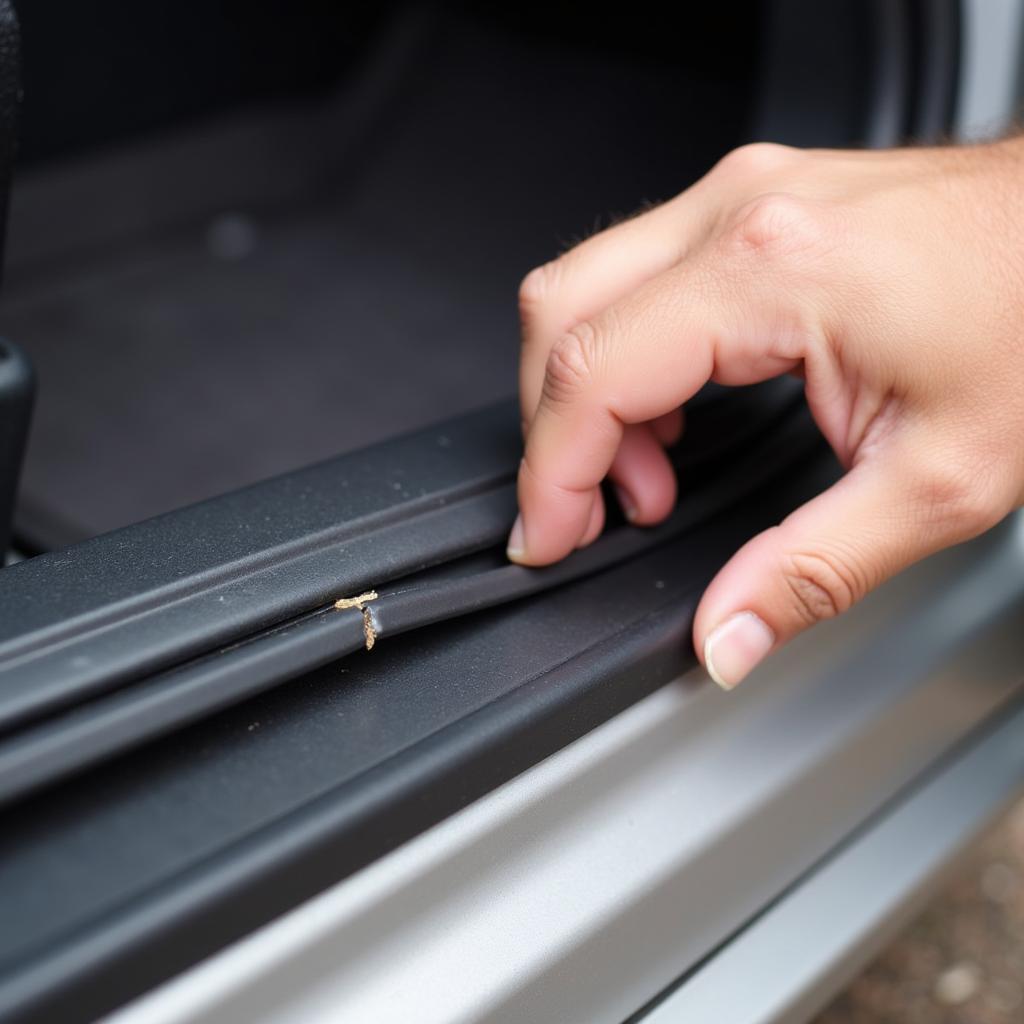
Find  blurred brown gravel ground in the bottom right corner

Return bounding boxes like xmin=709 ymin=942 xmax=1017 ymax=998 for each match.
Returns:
xmin=814 ymin=800 xmax=1024 ymax=1024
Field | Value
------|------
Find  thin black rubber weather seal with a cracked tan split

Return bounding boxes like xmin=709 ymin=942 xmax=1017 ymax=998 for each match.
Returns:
xmin=0 ymin=391 xmax=819 ymax=803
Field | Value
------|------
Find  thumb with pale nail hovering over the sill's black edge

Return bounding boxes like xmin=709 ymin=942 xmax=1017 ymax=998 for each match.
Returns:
xmin=693 ymin=446 xmax=977 ymax=689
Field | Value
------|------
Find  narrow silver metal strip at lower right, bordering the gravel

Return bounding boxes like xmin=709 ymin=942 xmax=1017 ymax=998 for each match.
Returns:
xmin=641 ymin=688 xmax=1024 ymax=1024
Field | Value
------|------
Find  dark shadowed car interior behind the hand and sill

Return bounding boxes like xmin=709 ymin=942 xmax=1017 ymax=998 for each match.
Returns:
xmin=0 ymin=0 xmax=759 ymax=550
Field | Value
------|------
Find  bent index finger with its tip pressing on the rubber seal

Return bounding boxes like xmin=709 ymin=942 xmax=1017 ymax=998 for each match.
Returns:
xmin=509 ymin=254 xmax=799 ymax=565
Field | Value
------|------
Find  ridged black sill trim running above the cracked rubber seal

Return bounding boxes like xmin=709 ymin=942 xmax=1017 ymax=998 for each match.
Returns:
xmin=0 ymin=381 xmax=800 ymax=736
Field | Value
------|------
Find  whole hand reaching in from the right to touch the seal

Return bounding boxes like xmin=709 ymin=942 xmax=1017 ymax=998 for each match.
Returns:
xmin=509 ymin=139 xmax=1024 ymax=689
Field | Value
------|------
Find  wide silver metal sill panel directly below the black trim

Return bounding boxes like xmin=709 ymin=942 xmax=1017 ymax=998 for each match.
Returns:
xmin=103 ymin=517 xmax=1024 ymax=1024
